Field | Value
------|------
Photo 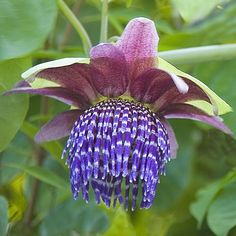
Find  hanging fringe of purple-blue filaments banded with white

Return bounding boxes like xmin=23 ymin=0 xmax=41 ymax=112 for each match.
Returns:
xmin=63 ymin=99 xmax=170 ymax=210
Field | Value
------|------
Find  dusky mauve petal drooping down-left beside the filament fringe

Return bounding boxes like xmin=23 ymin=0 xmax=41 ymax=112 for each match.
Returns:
xmin=35 ymin=110 xmax=83 ymax=143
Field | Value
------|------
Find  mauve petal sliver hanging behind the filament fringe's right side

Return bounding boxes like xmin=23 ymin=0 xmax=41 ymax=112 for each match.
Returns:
xmin=161 ymin=118 xmax=179 ymax=159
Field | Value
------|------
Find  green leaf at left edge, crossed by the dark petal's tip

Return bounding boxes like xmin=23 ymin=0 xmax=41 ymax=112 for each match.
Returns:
xmin=0 ymin=58 xmax=31 ymax=152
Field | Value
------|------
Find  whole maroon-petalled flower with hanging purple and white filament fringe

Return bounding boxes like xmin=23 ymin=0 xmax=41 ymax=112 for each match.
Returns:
xmin=9 ymin=18 xmax=231 ymax=210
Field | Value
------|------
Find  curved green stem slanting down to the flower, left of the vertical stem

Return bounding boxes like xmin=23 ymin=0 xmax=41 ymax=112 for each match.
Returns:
xmin=57 ymin=0 xmax=92 ymax=56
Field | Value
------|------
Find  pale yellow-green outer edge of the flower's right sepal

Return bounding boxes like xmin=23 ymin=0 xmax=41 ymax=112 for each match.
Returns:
xmin=158 ymin=57 xmax=232 ymax=115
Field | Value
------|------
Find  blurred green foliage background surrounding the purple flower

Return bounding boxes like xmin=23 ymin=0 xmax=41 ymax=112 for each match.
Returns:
xmin=0 ymin=0 xmax=236 ymax=236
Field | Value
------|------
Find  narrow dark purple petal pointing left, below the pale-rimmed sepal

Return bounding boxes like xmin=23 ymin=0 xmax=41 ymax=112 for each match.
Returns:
xmin=5 ymin=84 xmax=90 ymax=108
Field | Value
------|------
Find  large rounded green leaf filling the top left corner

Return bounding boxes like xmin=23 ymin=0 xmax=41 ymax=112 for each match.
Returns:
xmin=0 ymin=0 xmax=57 ymax=60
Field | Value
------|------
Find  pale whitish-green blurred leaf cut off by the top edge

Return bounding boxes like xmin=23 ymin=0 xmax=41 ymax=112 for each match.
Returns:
xmin=172 ymin=0 xmax=222 ymax=22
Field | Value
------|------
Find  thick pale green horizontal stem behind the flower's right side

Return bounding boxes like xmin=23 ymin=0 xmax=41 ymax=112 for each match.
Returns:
xmin=159 ymin=44 xmax=236 ymax=65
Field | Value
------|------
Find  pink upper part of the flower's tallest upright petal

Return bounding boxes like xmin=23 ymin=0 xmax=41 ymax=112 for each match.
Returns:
xmin=117 ymin=17 xmax=159 ymax=61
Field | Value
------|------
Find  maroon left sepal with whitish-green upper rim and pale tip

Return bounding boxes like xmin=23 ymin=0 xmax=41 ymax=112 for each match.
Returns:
xmin=22 ymin=58 xmax=97 ymax=103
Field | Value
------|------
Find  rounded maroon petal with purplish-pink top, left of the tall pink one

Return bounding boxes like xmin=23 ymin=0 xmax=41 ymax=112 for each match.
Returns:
xmin=90 ymin=44 xmax=128 ymax=97
